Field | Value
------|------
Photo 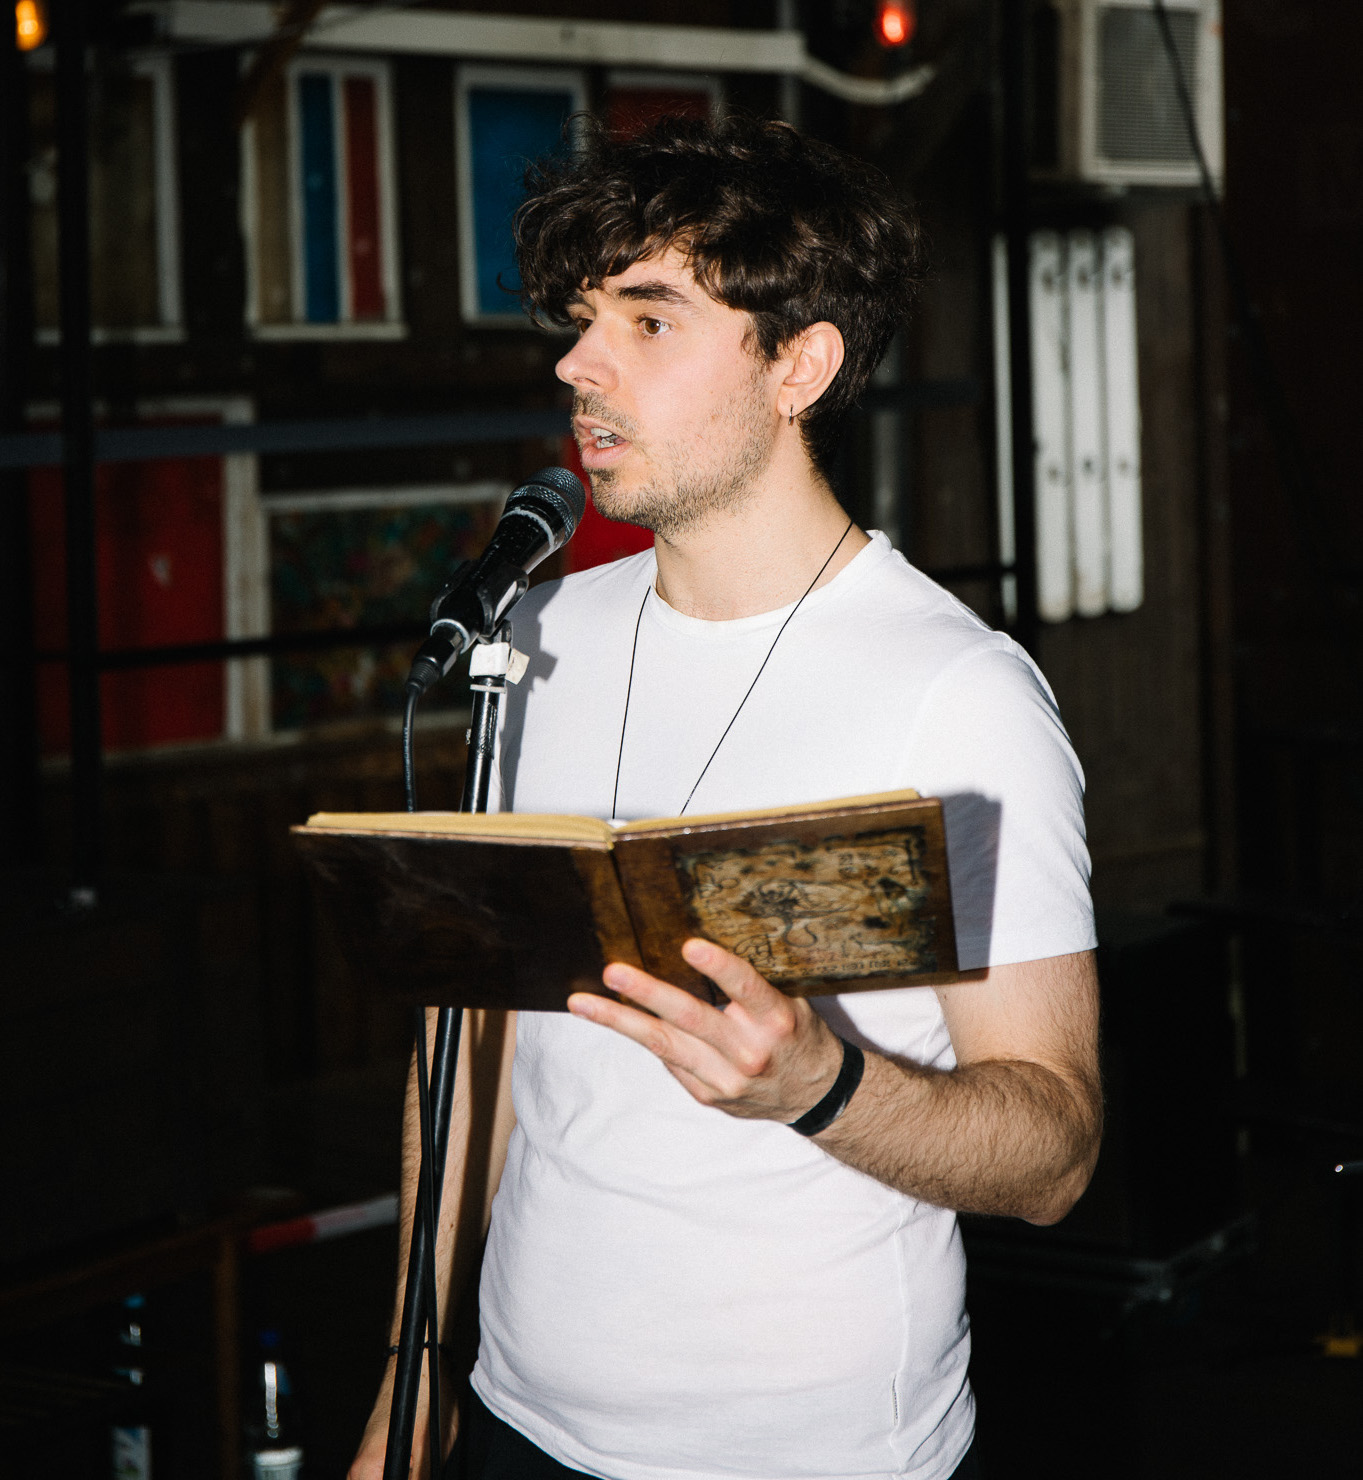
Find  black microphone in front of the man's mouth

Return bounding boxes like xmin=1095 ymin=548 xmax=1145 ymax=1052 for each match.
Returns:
xmin=407 ymin=468 xmax=588 ymax=694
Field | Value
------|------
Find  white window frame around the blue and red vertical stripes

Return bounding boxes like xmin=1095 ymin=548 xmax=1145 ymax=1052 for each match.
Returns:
xmin=241 ymin=52 xmax=407 ymax=339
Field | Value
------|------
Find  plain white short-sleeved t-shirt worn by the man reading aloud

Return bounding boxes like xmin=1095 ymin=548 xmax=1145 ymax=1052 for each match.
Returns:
xmin=474 ymin=534 xmax=1094 ymax=1480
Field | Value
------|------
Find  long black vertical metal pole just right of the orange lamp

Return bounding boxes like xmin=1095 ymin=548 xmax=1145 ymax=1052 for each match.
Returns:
xmin=53 ymin=0 xmax=101 ymax=909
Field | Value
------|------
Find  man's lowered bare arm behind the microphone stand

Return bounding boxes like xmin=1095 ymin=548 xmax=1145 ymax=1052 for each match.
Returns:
xmin=348 ymin=1008 xmax=516 ymax=1480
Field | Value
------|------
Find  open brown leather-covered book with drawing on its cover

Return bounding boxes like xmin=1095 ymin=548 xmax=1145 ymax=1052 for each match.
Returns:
xmin=293 ymin=792 xmax=956 ymax=1009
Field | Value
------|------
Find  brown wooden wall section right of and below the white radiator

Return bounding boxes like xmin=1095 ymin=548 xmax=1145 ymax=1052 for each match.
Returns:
xmin=1037 ymin=201 xmax=1208 ymax=910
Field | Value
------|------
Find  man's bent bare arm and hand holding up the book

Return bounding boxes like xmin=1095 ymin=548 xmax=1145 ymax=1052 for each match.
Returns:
xmin=568 ymin=940 xmax=1103 ymax=1222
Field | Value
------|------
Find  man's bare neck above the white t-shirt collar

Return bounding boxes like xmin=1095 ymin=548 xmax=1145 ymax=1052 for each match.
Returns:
xmin=656 ymin=471 xmax=869 ymax=622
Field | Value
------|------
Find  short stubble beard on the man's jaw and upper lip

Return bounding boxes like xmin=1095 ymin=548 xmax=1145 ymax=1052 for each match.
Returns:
xmin=573 ymin=371 xmax=775 ymax=540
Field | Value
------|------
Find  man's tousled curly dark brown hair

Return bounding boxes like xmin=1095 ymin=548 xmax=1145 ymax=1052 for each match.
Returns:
xmin=515 ymin=115 xmax=923 ymax=475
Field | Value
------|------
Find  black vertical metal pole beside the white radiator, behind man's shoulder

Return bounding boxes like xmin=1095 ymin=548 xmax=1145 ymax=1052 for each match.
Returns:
xmin=997 ymin=0 xmax=1037 ymax=656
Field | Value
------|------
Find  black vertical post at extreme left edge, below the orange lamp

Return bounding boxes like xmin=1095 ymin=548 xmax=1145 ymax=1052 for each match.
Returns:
xmin=0 ymin=30 xmax=41 ymax=863
